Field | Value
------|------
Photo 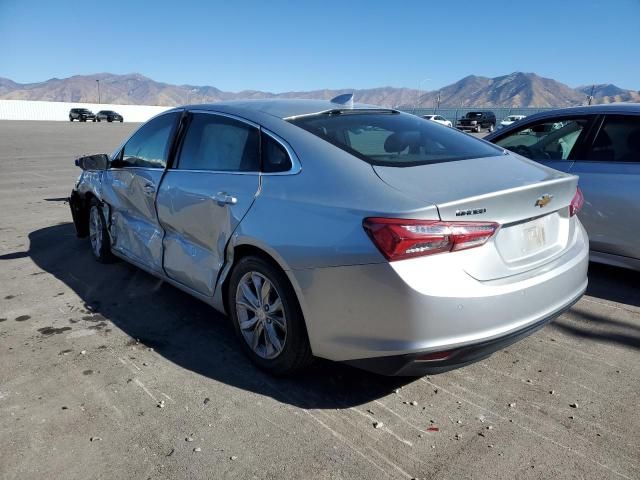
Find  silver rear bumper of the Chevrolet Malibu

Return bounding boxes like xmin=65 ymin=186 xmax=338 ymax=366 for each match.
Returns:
xmin=288 ymin=222 xmax=589 ymax=371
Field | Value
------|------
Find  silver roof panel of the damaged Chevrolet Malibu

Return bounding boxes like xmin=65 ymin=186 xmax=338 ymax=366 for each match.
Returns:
xmin=171 ymin=99 xmax=382 ymax=118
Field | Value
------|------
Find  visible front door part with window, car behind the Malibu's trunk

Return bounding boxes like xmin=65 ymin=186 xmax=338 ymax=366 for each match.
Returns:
xmin=492 ymin=115 xmax=597 ymax=172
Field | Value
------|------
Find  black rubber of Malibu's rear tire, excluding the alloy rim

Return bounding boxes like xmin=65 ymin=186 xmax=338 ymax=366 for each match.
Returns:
xmin=227 ymin=256 xmax=311 ymax=375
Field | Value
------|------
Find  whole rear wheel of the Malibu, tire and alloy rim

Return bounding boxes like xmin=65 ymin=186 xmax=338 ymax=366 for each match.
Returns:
xmin=227 ymin=256 xmax=313 ymax=375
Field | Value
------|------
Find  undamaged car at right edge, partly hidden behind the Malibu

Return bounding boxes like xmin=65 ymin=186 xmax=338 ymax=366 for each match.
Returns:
xmin=485 ymin=103 xmax=640 ymax=270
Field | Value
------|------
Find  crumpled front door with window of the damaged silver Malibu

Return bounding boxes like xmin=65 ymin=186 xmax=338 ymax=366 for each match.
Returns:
xmin=102 ymin=111 xmax=182 ymax=272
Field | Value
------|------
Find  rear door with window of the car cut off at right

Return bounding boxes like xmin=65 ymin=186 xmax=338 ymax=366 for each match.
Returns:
xmin=571 ymin=115 xmax=640 ymax=258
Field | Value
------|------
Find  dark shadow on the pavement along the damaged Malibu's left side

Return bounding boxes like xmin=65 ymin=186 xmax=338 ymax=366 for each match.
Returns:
xmin=5 ymin=223 xmax=413 ymax=409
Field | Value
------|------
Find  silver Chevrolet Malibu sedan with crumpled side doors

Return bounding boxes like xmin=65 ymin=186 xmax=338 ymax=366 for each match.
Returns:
xmin=70 ymin=100 xmax=588 ymax=375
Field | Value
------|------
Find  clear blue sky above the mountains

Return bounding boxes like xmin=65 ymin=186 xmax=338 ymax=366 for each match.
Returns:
xmin=0 ymin=0 xmax=640 ymax=92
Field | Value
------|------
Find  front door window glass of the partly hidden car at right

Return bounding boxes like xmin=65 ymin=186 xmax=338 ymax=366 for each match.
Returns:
xmin=495 ymin=118 xmax=588 ymax=161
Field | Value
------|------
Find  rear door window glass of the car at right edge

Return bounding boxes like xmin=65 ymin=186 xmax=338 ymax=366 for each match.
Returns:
xmin=586 ymin=115 xmax=640 ymax=162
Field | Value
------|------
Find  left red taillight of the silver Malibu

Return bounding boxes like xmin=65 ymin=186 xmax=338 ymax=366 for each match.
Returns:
xmin=363 ymin=217 xmax=499 ymax=261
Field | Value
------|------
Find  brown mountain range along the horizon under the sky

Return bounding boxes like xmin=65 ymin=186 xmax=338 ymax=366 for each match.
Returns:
xmin=0 ymin=72 xmax=640 ymax=108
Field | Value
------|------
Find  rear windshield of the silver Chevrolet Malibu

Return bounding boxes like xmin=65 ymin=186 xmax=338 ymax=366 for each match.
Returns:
xmin=289 ymin=111 xmax=502 ymax=167
